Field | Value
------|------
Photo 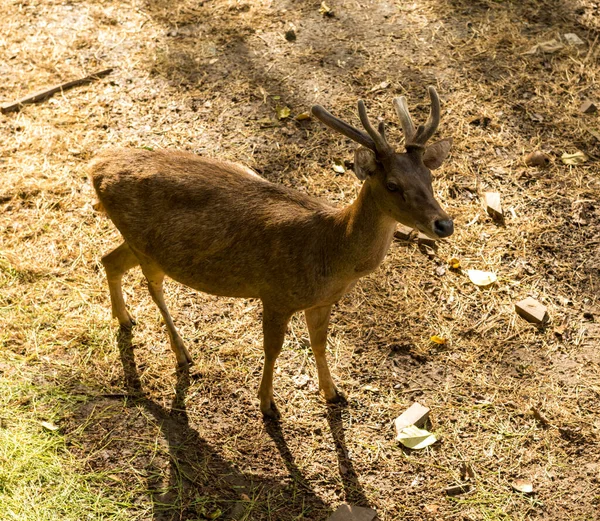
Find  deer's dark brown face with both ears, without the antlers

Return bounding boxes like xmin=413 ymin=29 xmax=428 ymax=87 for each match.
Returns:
xmin=355 ymin=140 xmax=454 ymax=239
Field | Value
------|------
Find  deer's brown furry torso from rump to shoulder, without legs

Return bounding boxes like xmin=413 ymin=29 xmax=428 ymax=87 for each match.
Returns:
xmin=90 ymin=150 xmax=336 ymax=301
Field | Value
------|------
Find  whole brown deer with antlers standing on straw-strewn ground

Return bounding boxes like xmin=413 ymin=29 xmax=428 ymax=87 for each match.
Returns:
xmin=89 ymin=87 xmax=454 ymax=420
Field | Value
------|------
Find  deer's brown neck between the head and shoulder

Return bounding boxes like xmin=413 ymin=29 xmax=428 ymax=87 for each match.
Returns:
xmin=337 ymin=180 xmax=396 ymax=278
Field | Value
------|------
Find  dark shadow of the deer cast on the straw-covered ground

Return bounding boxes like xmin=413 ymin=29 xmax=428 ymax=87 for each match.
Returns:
xmin=112 ymin=329 xmax=368 ymax=521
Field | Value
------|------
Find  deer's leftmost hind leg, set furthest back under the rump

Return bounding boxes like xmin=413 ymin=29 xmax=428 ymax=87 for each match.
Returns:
xmin=102 ymin=242 xmax=140 ymax=328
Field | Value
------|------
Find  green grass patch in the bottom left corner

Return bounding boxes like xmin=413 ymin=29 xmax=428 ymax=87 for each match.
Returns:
xmin=0 ymin=374 xmax=151 ymax=521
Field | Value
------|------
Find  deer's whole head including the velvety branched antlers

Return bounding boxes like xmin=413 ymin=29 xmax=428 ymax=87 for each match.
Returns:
xmin=312 ymin=87 xmax=454 ymax=238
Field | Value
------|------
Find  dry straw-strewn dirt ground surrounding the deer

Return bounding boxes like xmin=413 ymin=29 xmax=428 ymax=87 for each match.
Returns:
xmin=0 ymin=0 xmax=600 ymax=521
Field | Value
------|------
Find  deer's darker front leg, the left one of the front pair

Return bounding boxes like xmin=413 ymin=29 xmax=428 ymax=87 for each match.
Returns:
xmin=258 ymin=305 xmax=291 ymax=420
